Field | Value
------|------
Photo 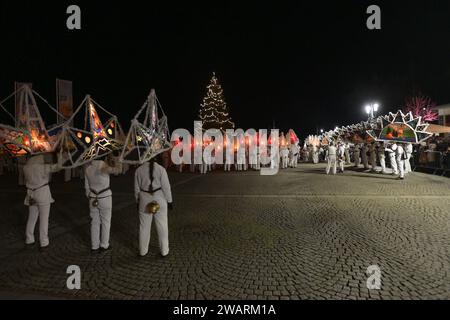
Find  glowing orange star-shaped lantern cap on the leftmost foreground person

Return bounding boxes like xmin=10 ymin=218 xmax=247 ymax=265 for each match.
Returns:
xmin=0 ymin=84 xmax=64 ymax=157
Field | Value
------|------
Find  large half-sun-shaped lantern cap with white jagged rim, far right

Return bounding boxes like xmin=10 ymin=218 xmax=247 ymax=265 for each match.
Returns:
xmin=367 ymin=110 xmax=432 ymax=144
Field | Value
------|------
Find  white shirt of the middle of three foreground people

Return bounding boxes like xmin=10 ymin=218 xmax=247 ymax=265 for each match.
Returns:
xmin=84 ymin=160 xmax=122 ymax=198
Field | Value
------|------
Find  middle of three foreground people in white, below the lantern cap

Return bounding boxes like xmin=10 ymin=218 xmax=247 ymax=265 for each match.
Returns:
xmin=84 ymin=160 xmax=122 ymax=252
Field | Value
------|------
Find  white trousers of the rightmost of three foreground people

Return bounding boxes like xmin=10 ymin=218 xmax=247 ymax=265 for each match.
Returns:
xmin=139 ymin=209 xmax=169 ymax=256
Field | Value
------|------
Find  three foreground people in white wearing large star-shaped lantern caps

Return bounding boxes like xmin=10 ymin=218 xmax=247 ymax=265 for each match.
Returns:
xmin=0 ymin=84 xmax=173 ymax=256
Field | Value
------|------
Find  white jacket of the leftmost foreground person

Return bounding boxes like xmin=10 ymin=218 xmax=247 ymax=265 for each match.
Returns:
xmin=23 ymin=156 xmax=59 ymax=206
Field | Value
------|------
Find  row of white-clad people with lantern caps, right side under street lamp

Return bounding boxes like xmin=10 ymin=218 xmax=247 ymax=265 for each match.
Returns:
xmin=301 ymin=110 xmax=439 ymax=180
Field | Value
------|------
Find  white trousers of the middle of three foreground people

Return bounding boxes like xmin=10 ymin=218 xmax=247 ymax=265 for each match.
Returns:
xmin=89 ymin=197 xmax=112 ymax=250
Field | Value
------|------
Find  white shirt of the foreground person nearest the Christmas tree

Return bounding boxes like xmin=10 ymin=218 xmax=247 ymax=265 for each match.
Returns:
xmin=134 ymin=162 xmax=172 ymax=203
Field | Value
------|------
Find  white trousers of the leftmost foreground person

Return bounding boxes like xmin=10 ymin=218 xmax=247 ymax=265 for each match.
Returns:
xmin=25 ymin=204 xmax=50 ymax=247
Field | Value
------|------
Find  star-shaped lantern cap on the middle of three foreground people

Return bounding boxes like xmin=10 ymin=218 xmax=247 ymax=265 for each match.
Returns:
xmin=59 ymin=95 xmax=125 ymax=168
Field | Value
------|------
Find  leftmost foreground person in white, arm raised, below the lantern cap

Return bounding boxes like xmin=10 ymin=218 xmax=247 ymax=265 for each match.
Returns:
xmin=23 ymin=155 xmax=61 ymax=249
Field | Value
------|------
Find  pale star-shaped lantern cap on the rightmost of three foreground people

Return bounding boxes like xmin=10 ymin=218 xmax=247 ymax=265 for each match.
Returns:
xmin=120 ymin=90 xmax=171 ymax=164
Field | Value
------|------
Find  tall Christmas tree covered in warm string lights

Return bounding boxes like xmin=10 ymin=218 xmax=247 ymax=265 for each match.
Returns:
xmin=199 ymin=73 xmax=234 ymax=131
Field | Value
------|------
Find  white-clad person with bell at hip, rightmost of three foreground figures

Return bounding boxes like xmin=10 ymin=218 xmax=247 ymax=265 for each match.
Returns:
xmin=134 ymin=160 xmax=172 ymax=257
